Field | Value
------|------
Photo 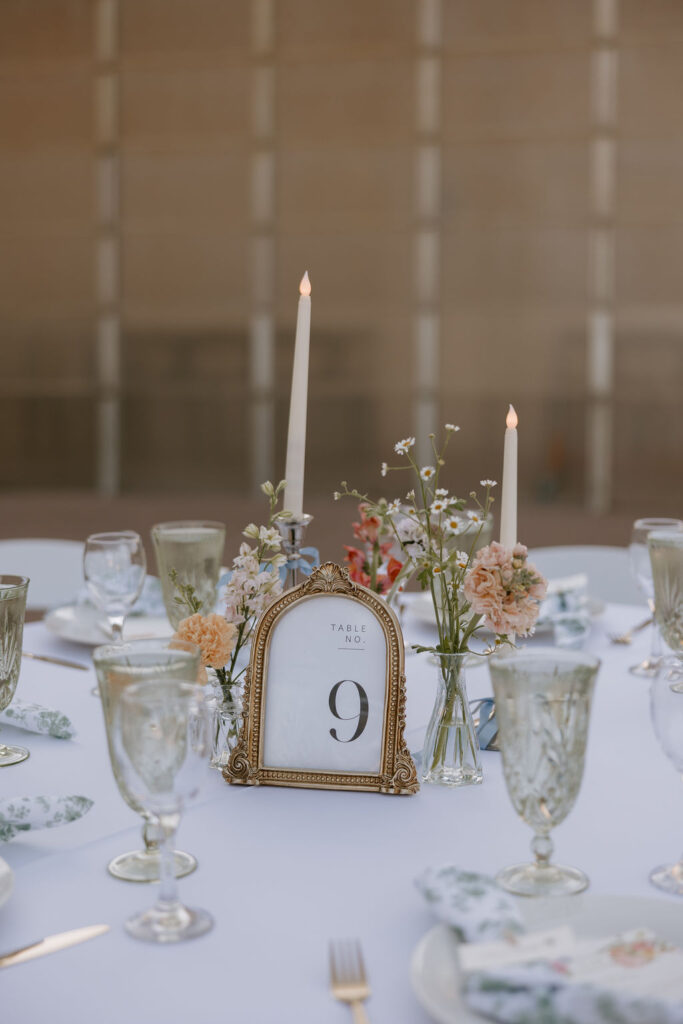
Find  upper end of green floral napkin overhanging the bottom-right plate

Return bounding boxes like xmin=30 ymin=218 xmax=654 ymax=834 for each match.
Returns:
xmin=415 ymin=864 xmax=524 ymax=942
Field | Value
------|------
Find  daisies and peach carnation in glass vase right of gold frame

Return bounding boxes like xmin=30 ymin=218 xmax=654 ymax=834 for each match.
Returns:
xmin=335 ymin=423 xmax=546 ymax=785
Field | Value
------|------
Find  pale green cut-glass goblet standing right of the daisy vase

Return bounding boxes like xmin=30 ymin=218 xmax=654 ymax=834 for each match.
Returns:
xmin=490 ymin=647 xmax=600 ymax=896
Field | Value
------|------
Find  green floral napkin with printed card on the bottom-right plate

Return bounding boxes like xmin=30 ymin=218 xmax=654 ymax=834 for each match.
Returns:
xmin=416 ymin=866 xmax=683 ymax=1024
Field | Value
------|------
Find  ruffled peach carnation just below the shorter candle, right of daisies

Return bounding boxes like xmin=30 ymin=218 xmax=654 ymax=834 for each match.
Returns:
xmin=463 ymin=541 xmax=547 ymax=636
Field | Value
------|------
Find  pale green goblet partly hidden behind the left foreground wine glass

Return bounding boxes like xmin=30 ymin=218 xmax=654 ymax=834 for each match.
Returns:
xmin=92 ymin=639 xmax=201 ymax=882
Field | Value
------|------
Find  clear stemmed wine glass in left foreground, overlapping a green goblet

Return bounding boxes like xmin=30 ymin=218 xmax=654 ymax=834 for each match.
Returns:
xmin=114 ymin=679 xmax=213 ymax=942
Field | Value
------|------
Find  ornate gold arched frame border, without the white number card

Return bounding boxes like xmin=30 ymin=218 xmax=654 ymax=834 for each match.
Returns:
xmin=223 ymin=562 xmax=420 ymax=796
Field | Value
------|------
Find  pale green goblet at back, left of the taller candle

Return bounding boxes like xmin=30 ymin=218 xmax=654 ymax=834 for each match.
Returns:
xmin=152 ymin=520 xmax=225 ymax=630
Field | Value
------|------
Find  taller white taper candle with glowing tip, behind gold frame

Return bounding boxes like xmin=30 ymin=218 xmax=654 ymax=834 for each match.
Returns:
xmin=284 ymin=270 xmax=310 ymax=516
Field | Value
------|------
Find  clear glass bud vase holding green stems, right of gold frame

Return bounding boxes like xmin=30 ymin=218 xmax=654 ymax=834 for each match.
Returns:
xmin=421 ymin=654 xmax=483 ymax=785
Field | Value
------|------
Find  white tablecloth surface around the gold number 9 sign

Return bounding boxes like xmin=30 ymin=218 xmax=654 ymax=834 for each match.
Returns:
xmin=0 ymin=605 xmax=683 ymax=1024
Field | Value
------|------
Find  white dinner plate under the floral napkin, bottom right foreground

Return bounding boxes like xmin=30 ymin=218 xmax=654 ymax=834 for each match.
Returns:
xmin=411 ymin=893 xmax=683 ymax=1024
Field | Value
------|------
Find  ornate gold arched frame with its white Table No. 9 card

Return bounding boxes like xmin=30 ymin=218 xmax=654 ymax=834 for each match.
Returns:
xmin=223 ymin=562 xmax=419 ymax=795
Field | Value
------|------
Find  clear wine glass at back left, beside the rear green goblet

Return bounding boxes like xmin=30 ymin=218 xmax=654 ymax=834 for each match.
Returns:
xmin=83 ymin=529 xmax=146 ymax=642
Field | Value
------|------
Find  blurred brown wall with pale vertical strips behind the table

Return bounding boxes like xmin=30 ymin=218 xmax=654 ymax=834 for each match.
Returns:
xmin=0 ymin=0 xmax=683 ymax=543
